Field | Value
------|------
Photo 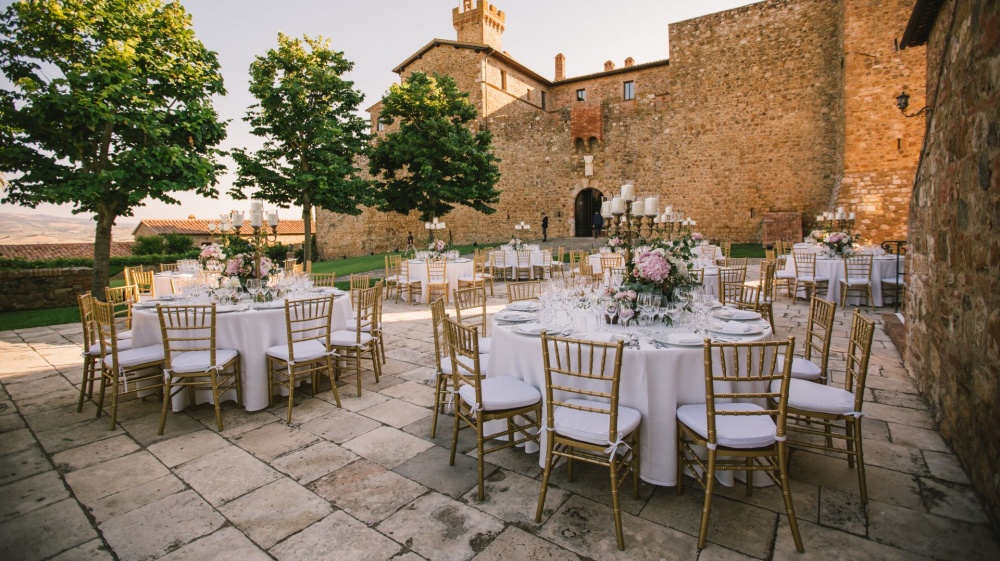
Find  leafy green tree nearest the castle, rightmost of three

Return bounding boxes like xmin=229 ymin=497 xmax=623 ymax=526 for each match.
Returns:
xmin=368 ymin=72 xmax=500 ymax=237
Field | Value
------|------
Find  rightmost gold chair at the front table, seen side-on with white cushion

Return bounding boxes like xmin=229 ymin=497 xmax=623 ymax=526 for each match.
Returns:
xmin=788 ymin=310 xmax=875 ymax=504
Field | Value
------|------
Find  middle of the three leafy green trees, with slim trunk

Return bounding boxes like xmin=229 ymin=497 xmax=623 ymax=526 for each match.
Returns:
xmin=231 ymin=33 xmax=374 ymax=261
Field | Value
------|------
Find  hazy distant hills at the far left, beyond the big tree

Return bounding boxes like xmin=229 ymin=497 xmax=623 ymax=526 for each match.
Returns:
xmin=0 ymin=212 xmax=139 ymax=245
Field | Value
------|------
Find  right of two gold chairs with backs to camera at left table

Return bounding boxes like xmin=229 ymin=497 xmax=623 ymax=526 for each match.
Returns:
xmin=267 ymin=296 xmax=340 ymax=424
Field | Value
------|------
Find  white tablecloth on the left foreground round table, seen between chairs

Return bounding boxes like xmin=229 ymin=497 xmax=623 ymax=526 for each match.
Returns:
xmin=132 ymin=293 xmax=354 ymax=411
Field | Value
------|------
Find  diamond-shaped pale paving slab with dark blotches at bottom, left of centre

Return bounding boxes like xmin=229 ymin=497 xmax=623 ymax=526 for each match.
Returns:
xmin=378 ymin=492 xmax=504 ymax=561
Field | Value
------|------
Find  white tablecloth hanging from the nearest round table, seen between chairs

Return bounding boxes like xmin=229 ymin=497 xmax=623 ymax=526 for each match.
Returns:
xmin=487 ymin=321 xmax=772 ymax=486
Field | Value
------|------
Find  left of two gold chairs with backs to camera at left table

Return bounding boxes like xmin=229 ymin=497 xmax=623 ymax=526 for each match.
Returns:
xmin=156 ymin=304 xmax=243 ymax=435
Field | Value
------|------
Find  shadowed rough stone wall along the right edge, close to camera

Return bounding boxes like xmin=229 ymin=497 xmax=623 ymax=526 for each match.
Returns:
xmin=905 ymin=0 xmax=1000 ymax=524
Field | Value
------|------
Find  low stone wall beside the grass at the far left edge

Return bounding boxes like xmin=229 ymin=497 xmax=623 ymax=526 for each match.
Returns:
xmin=0 ymin=267 xmax=93 ymax=312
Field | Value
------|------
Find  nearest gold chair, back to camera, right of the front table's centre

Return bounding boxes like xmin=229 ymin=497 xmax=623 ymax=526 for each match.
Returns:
xmin=677 ymin=337 xmax=804 ymax=552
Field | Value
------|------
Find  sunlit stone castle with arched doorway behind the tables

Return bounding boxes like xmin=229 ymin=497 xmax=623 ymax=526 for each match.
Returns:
xmin=318 ymin=0 xmax=922 ymax=257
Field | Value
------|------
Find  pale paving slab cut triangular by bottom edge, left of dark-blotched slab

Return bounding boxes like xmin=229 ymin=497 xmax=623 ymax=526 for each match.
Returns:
xmin=270 ymin=511 xmax=402 ymax=561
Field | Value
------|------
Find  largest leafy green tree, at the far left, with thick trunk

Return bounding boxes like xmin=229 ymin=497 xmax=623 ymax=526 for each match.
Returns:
xmin=0 ymin=0 xmax=225 ymax=295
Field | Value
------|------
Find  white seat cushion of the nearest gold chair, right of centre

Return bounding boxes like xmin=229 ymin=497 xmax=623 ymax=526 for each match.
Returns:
xmin=677 ymin=403 xmax=777 ymax=448
